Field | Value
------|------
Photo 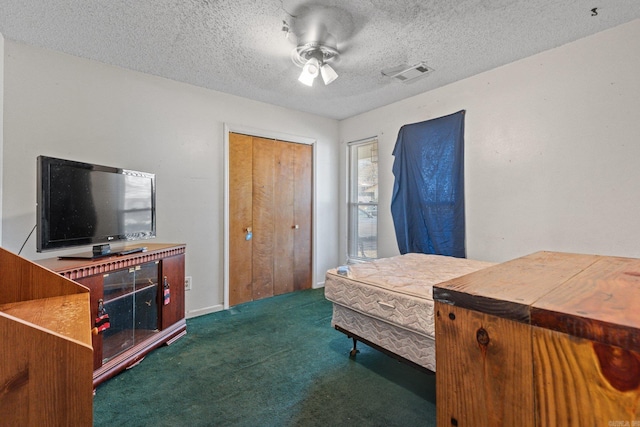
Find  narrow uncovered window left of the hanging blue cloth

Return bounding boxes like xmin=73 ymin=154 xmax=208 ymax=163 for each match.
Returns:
xmin=348 ymin=140 xmax=378 ymax=259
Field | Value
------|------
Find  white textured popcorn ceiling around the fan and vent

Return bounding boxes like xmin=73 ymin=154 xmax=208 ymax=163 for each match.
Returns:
xmin=0 ymin=0 xmax=640 ymax=119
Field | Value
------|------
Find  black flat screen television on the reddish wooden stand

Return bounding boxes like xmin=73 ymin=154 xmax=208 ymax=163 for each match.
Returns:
xmin=36 ymin=156 xmax=156 ymax=255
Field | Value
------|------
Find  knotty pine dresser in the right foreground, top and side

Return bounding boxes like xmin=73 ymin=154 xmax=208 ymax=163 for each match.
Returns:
xmin=433 ymin=252 xmax=640 ymax=427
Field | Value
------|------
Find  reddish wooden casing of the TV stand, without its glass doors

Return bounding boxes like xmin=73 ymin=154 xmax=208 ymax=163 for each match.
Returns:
xmin=37 ymin=242 xmax=187 ymax=387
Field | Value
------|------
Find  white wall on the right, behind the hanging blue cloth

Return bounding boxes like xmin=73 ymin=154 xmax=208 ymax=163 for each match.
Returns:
xmin=340 ymin=20 xmax=640 ymax=261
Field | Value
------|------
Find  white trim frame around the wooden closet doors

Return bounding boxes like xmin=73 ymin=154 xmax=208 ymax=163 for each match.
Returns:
xmin=223 ymin=123 xmax=318 ymax=310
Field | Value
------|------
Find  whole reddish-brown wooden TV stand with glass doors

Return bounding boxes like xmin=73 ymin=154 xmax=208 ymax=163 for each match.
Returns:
xmin=36 ymin=244 xmax=187 ymax=387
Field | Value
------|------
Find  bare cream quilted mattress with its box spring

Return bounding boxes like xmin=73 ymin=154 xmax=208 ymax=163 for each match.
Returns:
xmin=325 ymin=254 xmax=493 ymax=371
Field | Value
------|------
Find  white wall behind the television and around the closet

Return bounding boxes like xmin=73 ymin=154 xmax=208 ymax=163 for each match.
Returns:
xmin=2 ymin=40 xmax=339 ymax=316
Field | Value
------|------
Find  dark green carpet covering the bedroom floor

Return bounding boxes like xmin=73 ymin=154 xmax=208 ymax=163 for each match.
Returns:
xmin=94 ymin=289 xmax=435 ymax=426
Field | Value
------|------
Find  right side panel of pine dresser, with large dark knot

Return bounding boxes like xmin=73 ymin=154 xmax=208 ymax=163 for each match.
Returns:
xmin=533 ymin=327 xmax=640 ymax=427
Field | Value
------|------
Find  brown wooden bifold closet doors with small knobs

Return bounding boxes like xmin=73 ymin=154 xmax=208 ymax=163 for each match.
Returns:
xmin=229 ymin=133 xmax=313 ymax=306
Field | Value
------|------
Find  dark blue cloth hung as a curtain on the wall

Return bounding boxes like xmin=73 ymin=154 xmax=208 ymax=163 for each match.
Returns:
xmin=391 ymin=110 xmax=466 ymax=258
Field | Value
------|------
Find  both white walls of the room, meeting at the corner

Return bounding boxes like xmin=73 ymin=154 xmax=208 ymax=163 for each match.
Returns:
xmin=6 ymin=17 xmax=640 ymax=315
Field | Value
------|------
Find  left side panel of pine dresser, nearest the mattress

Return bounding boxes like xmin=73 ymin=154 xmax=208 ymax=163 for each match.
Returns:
xmin=435 ymin=302 xmax=534 ymax=427
